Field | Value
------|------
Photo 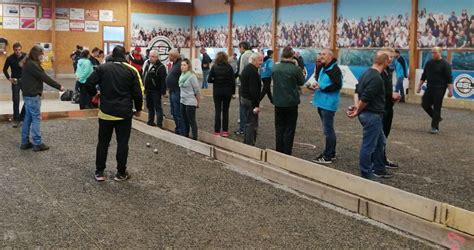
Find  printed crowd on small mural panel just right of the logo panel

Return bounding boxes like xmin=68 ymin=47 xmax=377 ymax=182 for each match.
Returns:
xmin=193 ymin=26 xmax=229 ymax=48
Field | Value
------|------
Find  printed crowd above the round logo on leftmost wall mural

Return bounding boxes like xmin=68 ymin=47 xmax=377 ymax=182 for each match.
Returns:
xmin=132 ymin=24 xmax=191 ymax=48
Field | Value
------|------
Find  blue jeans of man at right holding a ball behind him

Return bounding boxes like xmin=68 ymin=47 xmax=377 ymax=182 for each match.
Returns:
xmin=359 ymin=112 xmax=386 ymax=179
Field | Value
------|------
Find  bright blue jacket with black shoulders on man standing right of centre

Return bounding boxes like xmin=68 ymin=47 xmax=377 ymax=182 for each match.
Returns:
xmin=313 ymin=60 xmax=342 ymax=112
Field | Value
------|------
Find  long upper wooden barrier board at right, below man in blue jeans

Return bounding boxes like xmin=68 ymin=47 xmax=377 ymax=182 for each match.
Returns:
xmin=266 ymin=150 xmax=441 ymax=223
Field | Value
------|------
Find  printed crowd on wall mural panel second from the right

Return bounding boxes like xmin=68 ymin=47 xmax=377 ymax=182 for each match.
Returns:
xmin=336 ymin=13 xmax=410 ymax=48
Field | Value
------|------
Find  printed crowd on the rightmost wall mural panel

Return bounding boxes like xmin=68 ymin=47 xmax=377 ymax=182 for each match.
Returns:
xmin=417 ymin=9 xmax=474 ymax=48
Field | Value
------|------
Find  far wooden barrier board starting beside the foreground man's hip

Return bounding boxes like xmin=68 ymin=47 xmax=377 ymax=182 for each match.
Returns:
xmin=132 ymin=120 xmax=214 ymax=157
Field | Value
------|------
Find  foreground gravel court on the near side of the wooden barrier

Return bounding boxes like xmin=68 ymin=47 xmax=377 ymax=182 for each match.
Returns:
xmin=0 ymin=119 xmax=432 ymax=249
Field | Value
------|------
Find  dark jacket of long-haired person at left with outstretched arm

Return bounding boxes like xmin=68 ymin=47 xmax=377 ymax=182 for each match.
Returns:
xmin=21 ymin=59 xmax=61 ymax=97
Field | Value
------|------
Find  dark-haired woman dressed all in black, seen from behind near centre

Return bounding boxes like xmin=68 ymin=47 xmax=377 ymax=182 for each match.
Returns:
xmin=208 ymin=52 xmax=235 ymax=137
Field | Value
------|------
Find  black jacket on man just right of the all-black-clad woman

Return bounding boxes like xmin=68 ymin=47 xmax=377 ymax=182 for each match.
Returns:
xmin=240 ymin=63 xmax=262 ymax=108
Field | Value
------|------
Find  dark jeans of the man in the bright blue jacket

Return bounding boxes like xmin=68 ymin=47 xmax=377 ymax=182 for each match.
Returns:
xmin=318 ymin=108 xmax=336 ymax=160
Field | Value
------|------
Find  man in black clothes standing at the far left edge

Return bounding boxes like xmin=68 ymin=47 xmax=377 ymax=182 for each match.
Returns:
xmin=3 ymin=43 xmax=26 ymax=128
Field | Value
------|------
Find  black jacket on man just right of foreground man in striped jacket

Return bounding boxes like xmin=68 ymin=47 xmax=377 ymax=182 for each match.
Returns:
xmin=143 ymin=60 xmax=166 ymax=95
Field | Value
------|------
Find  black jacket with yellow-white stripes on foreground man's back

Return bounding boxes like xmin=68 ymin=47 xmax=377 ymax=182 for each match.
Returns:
xmin=86 ymin=58 xmax=143 ymax=118
